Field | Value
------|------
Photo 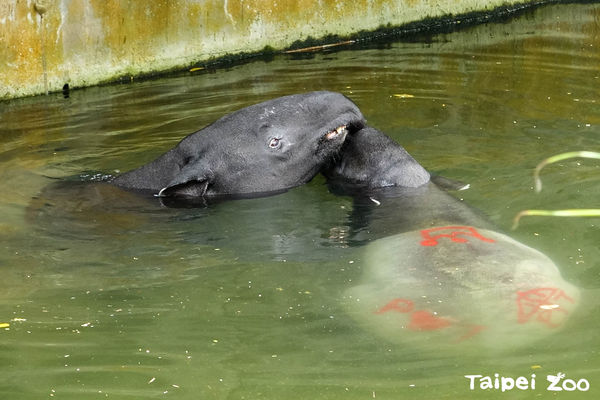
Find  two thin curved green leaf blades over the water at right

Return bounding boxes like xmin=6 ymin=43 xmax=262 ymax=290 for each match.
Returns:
xmin=512 ymin=151 xmax=600 ymax=230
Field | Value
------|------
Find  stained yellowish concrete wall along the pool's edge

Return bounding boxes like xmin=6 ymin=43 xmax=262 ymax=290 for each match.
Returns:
xmin=0 ymin=0 xmax=544 ymax=99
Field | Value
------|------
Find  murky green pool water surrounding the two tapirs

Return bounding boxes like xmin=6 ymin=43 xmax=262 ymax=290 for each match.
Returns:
xmin=0 ymin=4 xmax=600 ymax=399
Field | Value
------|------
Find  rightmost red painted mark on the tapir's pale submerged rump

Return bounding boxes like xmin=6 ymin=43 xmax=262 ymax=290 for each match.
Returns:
xmin=517 ymin=288 xmax=575 ymax=328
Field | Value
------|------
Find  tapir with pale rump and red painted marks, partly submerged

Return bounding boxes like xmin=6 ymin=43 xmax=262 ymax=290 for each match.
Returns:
xmin=325 ymin=129 xmax=579 ymax=354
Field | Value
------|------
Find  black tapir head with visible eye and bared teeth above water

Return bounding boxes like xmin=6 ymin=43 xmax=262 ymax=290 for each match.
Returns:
xmin=112 ymin=92 xmax=364 ymax=197
